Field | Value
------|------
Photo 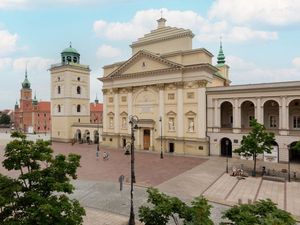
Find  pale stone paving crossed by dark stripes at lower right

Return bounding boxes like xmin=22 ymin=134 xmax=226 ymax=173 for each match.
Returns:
xmin=203 ymin=174 xmax=300 ymax=217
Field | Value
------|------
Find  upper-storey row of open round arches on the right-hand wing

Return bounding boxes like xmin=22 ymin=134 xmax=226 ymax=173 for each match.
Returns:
xmin=214 ymin=97 xmax=300 ymax=135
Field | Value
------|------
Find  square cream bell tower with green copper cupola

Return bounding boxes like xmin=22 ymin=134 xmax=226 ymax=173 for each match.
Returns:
xmin=50 ymin=43 xmax=90 ymax=142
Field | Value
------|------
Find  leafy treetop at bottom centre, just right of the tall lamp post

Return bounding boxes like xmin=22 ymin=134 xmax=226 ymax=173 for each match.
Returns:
xmin=139 ymin=188 xmax=213 ymax=225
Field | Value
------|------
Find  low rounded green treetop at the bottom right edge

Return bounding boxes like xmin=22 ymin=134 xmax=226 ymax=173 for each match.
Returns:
xmin=221 ymin=199 xmax=296 ymax=225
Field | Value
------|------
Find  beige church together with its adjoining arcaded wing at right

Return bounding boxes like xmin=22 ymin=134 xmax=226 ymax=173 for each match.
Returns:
xmin=100 ymin=18 xmax=300 ymax=162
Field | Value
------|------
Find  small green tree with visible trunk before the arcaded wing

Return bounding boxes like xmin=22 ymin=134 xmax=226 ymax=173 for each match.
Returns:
xmin=234 ymin=119 xmax=275 ymax=176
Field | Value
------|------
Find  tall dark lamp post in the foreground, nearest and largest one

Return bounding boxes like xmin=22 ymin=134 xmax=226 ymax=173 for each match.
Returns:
xmin=128 ymin=116 xmax=139 ymax=225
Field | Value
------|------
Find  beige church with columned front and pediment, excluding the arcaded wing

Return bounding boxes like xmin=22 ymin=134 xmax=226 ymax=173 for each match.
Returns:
xmin=100 ymin=18 xmax=228 ymax=155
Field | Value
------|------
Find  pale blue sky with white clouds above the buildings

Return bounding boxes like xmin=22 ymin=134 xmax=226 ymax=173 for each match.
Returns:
xmin=0 ymin=0 xmax=300 ymax=109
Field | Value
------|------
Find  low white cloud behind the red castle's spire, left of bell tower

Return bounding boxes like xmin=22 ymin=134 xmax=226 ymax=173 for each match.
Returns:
xmin=12 ymin=56 xmax=55 ymax=71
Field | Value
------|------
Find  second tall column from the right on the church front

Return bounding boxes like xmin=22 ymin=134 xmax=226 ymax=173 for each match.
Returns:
xmin=176 ymin=82 xmax=185 ymax=138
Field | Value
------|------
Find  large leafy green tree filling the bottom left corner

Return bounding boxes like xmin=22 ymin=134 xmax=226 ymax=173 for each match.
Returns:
xmin=0 ymin=132 xmax=85 ymax=225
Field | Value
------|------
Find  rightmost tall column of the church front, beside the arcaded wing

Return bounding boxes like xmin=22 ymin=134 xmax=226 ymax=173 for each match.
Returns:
xmin=197 ymin=80 xmax=207 ymax=138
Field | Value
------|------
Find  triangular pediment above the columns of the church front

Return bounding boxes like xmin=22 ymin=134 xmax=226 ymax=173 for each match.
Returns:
xmin=109 ymin=50 xmax=182 ymax=77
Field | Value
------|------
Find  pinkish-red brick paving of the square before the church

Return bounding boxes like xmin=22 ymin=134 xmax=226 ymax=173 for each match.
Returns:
xmin=0 ymin=143 xmax=206 ymax=186
